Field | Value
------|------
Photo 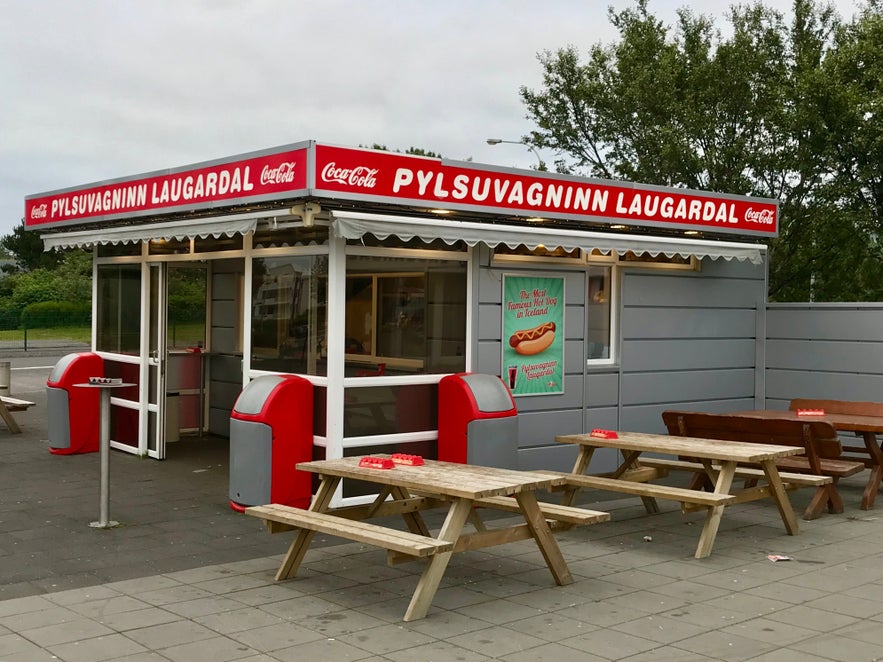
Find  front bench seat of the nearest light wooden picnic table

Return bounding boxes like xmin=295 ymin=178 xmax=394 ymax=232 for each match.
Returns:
xmin=245 ymin=503 xmax=454 ymax=557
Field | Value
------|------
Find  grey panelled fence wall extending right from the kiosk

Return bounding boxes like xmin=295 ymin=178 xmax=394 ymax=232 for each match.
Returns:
xmin=765 ymin=303 xmax=883 ymax=409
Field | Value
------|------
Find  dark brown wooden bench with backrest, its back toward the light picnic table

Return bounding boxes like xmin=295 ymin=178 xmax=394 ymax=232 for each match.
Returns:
xmin=662 ymin=411 xmax=865 ymax=519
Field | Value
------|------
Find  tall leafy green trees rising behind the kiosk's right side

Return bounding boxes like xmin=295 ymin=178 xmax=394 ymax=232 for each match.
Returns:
xmin=521 ymin=0 xmax=883 ymax=300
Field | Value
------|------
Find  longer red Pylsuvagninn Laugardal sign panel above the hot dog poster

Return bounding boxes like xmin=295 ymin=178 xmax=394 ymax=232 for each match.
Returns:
xmin=315 ymin=145 xmax=778 ymax=236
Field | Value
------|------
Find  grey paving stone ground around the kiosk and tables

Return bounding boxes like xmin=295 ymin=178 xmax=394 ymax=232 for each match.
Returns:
xmin=0 ymin=360 xmax=883 ymax=662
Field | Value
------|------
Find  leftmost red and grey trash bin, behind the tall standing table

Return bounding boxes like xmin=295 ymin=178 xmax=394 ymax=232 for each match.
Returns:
xmin=46 ymin=352 xmax=104 ymax=455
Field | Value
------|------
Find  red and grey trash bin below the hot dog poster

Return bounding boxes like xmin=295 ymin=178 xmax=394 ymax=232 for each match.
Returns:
xmin=438 ymin=372 xmax=518 ymax=469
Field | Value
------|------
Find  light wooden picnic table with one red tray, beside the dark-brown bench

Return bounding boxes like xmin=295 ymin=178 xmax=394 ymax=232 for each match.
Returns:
xmin=555 ymin=432 xmax=801 ymax=559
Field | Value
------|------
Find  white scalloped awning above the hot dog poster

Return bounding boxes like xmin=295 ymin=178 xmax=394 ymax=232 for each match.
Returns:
xmin=331 ymin=211 xmax=766 ymax=264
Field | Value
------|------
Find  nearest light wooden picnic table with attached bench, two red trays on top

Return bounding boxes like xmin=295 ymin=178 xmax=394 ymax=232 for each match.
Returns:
xmin=246 ymin=457 xmax=580 ymax=621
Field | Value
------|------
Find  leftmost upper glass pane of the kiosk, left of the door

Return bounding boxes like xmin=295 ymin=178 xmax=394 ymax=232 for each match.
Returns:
xmin=96 ymin=264 xmax=141 ymax=355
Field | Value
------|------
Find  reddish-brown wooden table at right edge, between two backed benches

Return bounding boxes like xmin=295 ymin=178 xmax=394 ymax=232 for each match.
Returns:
xmin=733 ymin=399 xmax=883 ymax=510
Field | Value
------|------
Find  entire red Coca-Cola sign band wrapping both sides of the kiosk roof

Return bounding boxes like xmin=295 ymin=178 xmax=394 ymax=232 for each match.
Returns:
xmin=25 ymin=143 xmax=778 ymax=236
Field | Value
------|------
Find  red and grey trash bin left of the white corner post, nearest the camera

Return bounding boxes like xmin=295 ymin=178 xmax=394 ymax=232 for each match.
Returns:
xmin=230 ymin=375 xmax=313 ymax=512
